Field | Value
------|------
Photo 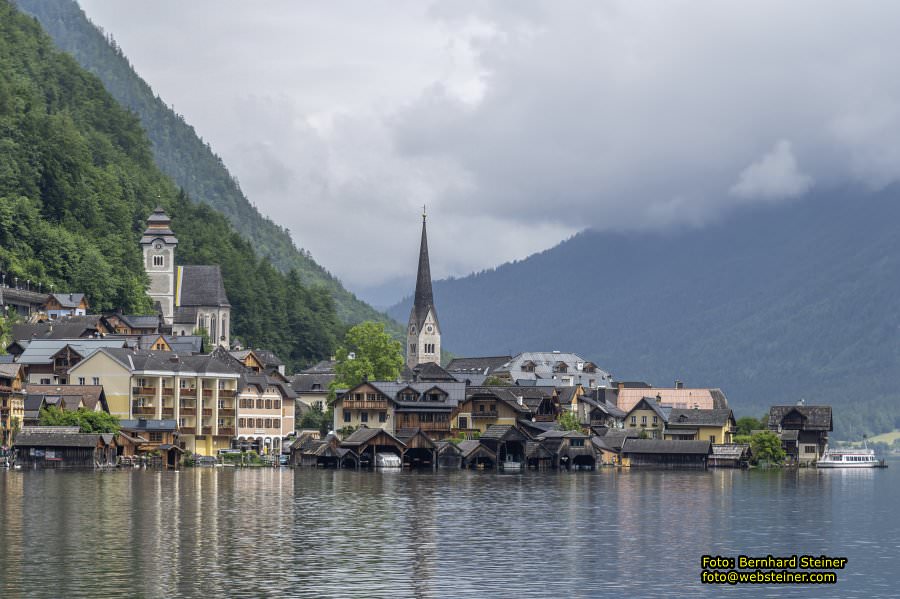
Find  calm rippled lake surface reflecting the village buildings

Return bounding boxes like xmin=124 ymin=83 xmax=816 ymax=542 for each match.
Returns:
xmin=0 ymin=461 xmax=900 ymax=598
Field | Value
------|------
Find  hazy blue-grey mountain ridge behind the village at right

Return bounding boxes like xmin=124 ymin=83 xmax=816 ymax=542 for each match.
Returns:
xmin=388 ymin=188 xmax=900 ymax=438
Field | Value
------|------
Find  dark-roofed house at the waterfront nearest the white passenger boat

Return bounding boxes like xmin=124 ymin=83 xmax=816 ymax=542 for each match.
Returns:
xmin=768 ymin=405 xmax=834 ymax=464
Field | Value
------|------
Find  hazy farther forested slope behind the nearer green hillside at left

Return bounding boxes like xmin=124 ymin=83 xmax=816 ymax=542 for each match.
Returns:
xmin=17 ymin=0 xmax=400 ymax=332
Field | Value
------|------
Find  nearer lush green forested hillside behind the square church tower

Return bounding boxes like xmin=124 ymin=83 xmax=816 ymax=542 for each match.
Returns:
xmin=0 ymin=0 xmax=343 ymax=366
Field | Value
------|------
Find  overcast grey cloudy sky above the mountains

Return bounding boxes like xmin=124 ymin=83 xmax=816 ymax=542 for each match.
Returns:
xmin=81 ymin=0 xmax=900 ymax=299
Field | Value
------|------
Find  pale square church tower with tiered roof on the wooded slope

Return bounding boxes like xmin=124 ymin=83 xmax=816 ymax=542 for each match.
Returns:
xmin=141 ymin=207 xmax=178 ymax=325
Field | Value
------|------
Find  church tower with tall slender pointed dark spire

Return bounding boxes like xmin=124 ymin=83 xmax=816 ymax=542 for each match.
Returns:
xmin=406 ymin=212 xmax=441 ymax=368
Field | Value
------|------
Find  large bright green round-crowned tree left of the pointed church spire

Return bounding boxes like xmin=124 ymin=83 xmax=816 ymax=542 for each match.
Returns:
xmin=329 ymin=320 xmax=403 ymax=399
